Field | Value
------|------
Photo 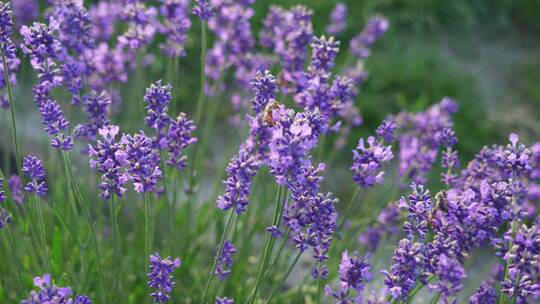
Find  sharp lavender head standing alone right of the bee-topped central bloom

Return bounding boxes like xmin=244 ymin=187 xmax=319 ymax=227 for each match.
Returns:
xmin=351 ymin=136 xmax=394 ymax=187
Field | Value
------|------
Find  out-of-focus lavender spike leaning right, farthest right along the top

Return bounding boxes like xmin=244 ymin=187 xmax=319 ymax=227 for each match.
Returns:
xmin=351 ymin=16 xmax=388 ymax=59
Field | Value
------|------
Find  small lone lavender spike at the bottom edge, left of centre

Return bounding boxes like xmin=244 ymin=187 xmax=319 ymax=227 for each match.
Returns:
xmin=148 ymin=253 xmax=181 ymax=303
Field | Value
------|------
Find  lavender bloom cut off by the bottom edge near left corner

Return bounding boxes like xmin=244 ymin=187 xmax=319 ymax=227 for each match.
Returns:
xmin=21 ymin=273 xmax=92 ymax=304
